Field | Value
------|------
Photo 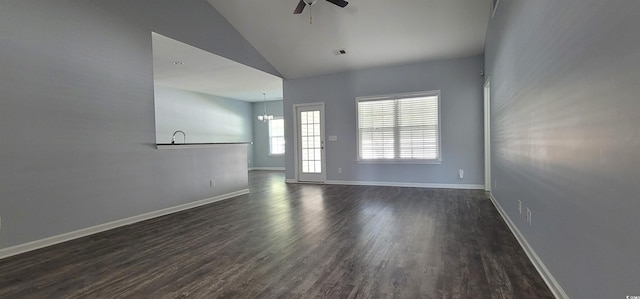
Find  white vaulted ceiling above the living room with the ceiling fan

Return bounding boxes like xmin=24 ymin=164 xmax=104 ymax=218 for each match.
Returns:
xmin=208 ymin=0 xmax=492 ymax=79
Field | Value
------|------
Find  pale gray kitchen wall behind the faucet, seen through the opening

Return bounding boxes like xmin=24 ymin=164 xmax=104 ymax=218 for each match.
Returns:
xmin=155 ymin=86 xmax=253 ymax=143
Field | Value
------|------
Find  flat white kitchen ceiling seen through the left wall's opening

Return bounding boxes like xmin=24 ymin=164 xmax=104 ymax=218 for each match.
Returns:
xmin=152 ymin=33 xmax=282 ymax=102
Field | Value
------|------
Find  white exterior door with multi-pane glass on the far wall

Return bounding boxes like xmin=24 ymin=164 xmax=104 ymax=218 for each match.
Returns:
xmin=294 ymin=103 xmax=327 ymax=182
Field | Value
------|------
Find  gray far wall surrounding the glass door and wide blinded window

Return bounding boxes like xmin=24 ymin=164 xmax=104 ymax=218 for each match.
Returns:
xmin=284 ymin=56 xmax=484 ymax=184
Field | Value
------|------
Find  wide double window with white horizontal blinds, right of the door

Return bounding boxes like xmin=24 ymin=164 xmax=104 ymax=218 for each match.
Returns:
xmin=356 ymin=91 xmax=440 ymax=163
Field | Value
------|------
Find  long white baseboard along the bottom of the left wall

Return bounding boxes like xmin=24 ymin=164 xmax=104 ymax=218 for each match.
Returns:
xmin=0 ymin=189 xmax=249 ymax=259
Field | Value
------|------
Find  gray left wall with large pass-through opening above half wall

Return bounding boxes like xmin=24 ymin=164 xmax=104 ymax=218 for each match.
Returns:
xmin=0 ymin=0 xmax=278 ymax=248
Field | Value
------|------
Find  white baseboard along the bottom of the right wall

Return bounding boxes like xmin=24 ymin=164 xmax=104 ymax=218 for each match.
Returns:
xmin=490 ymin=194 xmax=569 ymax=298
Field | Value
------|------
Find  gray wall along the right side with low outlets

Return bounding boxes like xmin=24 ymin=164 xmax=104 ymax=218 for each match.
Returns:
xmin=486 ymin=0 xmax=640 ymax=298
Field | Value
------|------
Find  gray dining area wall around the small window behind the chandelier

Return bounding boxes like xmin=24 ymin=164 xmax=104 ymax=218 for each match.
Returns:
xmin=251 ymin=101 xmax=284 ymax=168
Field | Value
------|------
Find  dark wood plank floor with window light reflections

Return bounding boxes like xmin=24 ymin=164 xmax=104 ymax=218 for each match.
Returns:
xmin=0 ymin=171 xmax=552 ymax=298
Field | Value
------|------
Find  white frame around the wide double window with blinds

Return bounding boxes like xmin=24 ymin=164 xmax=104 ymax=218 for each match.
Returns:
xmin=355 ymin=90 xmax=442 ymax=164
